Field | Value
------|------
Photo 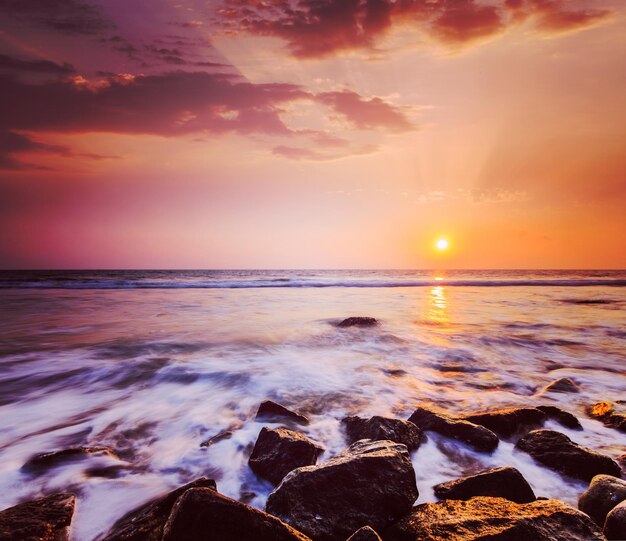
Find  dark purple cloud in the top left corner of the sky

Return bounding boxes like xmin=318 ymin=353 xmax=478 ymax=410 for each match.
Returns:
xmin=0 ymin=0 xmax=113 ymax=35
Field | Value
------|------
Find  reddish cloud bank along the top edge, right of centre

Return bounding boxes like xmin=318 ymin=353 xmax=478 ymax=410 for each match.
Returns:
xmin=216 ymin=0 xmax=609 ymax=58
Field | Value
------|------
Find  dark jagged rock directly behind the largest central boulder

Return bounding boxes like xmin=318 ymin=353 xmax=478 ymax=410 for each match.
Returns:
xmin=341 ymin=415 xmax=424 ymax=451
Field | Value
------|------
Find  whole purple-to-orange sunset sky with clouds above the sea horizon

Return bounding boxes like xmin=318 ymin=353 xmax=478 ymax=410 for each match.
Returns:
xmin=0 ymin=0 xmax=626 ymax=269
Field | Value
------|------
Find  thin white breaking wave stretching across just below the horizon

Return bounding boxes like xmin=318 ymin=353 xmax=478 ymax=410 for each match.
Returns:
xmin=0 ymin=279 xmax=626 ymax=288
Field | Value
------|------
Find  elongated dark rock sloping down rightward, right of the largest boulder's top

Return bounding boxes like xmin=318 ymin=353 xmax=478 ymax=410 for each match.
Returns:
xmin=409 ymin=407 xmax=499 ymax=452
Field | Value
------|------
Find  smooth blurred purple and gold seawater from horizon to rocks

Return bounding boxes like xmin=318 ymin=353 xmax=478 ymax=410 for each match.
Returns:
xmin=0 ymin=271 xmax=626 ymax=541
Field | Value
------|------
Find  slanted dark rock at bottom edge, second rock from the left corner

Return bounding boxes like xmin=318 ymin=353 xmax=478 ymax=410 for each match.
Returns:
xmin=98 ymin=477 xmax=217 ymax=541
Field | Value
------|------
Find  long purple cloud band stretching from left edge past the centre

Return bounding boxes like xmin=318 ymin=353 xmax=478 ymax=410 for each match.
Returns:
xmin=0 ymin=57 xmax=412 ymax=169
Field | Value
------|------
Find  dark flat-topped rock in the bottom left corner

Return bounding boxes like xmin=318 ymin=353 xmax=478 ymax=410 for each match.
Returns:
xmin=0 ymin=493 xmax=76 ymax=541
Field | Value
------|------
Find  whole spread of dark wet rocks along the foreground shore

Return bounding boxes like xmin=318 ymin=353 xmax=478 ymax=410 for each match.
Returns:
xmin=0 ymin=392 xmax=626 ymax=541
